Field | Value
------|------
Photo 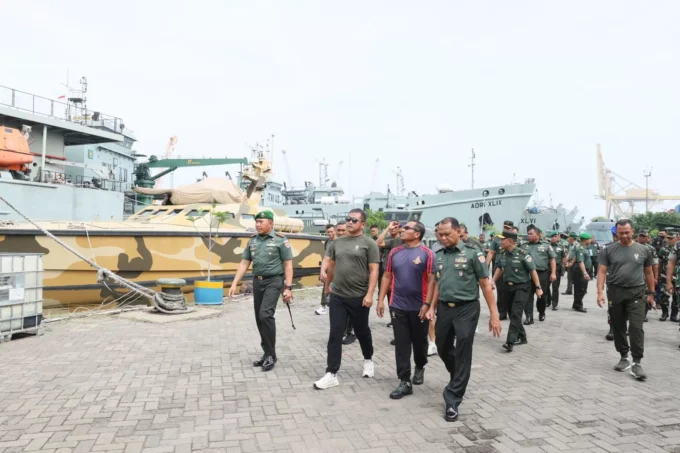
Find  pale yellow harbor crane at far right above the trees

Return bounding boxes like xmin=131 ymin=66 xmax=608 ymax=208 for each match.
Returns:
xmin=597 ymin=144 xmax=680 ymax=219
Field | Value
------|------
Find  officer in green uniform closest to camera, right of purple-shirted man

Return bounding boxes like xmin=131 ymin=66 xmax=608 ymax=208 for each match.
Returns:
xmin=425 ymin=217 xmax=500 ymax=422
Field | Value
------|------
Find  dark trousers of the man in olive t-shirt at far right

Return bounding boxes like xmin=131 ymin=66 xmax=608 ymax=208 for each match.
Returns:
xmin=607 ymin=285 xmax=647 ymax=362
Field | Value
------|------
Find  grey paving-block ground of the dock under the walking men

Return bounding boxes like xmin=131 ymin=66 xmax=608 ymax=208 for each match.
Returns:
xmin=0 ymin=288 xmax=680 ymax=453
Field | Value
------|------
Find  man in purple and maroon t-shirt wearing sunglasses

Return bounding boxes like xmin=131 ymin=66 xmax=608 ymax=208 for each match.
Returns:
xmin=376 ymin=222 xmax=434 ymax=399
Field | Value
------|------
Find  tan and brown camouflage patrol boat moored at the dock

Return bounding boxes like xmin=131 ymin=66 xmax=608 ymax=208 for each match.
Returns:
xmin=0 ymin=155 xmax=324 ymax=308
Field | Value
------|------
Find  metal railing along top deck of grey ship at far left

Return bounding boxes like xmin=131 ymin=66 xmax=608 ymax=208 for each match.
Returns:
xmin=0 ymin=85 xmax=133 ymax=135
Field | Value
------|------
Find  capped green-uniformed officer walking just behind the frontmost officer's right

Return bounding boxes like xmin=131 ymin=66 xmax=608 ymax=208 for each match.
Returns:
xmin=493 ymin=231 xmax=543 ymax=352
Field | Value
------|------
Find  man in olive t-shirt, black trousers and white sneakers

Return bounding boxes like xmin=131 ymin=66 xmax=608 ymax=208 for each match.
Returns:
xmin=314 ymin=209 xmax=380 ymax=389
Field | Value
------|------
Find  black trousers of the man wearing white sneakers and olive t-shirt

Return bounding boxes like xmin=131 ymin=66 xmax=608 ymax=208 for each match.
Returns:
xmin=326 ymin=293 xmax=373 ymax=374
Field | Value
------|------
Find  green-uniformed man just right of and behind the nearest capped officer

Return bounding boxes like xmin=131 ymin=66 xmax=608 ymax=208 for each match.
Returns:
xmin=521 ymin=225 xmax=557 ymax=325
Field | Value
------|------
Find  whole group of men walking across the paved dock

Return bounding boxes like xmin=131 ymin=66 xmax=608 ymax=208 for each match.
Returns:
xmin=229 ymin=209 xmax=680 ymax=421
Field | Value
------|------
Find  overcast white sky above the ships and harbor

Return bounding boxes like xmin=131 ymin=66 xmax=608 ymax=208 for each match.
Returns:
xmin=5 ymin=0 xmax=680 ymax=218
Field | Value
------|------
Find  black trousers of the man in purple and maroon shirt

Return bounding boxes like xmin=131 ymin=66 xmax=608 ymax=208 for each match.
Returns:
xmin=392 ymin=308 xmax=429 ymax=381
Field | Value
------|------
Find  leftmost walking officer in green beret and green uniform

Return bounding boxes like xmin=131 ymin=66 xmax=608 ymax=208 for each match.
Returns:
xmin=229 ymin=211 xmax=293 ymax=371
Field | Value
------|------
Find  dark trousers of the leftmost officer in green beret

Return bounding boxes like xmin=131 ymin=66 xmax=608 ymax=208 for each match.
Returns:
xmin=253 ymin=276 xmax=283 ymax=357
